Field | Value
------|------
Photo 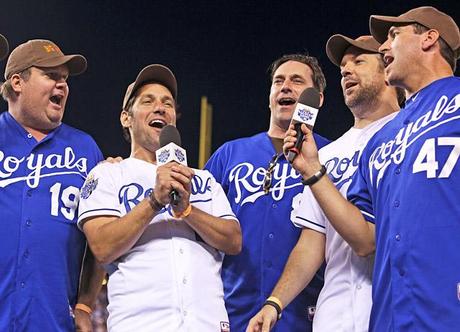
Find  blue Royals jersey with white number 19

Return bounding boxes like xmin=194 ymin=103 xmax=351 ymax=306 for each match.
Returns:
xmin=0 ymin=112 xmax=102 ymax=332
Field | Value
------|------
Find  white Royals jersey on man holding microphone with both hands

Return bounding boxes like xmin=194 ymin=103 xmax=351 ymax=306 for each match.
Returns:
xmin=79 ymin=158 xmax=236 ymax=332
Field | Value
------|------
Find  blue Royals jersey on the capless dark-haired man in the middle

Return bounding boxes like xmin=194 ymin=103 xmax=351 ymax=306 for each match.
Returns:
xmin=206 ymin=133 xmax=328 ymax=332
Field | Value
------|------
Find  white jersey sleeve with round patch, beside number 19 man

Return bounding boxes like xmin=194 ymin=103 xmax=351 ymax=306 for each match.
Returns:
xmin=78 ymin=163 xmax=121 ymax=229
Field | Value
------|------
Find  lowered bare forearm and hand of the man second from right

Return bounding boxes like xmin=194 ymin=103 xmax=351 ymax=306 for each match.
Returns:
xmin=246 ymin=228 xmax=326 ymax=332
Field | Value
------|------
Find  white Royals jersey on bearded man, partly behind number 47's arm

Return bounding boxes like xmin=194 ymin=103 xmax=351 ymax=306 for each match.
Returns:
xmin=291 ymin=113 xmax=396 ymax=332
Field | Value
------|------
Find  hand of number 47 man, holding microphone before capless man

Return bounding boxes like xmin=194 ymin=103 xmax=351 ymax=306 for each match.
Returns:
xmin=283 ymin=124 xmax=321 ymax=179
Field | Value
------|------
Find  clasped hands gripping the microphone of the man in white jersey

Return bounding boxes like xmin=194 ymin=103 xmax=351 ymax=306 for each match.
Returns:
xmin=154 ymin=162 xmax=195 ymax=214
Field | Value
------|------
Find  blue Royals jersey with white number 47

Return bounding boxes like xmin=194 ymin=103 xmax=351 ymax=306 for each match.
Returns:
xmin=348 ymin=77 xmax=460 ymax=332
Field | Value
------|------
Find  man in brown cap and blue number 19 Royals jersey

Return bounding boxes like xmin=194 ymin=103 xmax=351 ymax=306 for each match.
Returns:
xmin=0 ymin=40 xmax=102 ymax=331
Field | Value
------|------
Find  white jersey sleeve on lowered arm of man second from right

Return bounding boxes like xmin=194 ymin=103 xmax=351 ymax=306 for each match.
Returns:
xmin=291 ymin=186 xmax=327 ymax=234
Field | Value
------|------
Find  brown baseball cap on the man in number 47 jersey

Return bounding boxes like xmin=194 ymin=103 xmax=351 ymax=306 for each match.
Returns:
xmin=369 ymin=6 xmax=460 ymax=58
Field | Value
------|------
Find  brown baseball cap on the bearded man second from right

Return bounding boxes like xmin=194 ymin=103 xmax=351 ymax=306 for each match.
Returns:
xmin=326 ymin=34 xmax=380 ymax=67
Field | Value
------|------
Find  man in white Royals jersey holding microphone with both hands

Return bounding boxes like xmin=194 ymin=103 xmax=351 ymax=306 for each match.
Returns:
xmin=79 ymin=64 xmax=241 ymax=332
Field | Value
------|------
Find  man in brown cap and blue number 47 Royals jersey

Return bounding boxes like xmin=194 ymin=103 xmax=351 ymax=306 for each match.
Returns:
xmin=284 ymin=7 xmax=460 ymax=331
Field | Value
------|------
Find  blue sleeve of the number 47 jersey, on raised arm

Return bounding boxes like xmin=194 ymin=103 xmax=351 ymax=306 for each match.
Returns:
xmin=347 ymin=149 xmax=375 ymax=224
